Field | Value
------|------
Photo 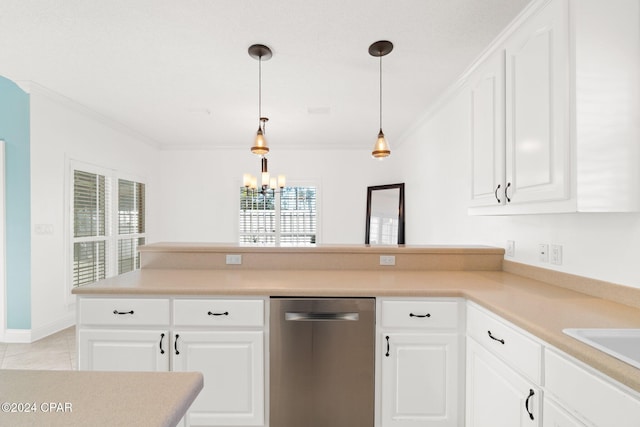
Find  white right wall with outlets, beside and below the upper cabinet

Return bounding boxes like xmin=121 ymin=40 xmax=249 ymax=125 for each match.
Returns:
xmin=396 ymin=85 xmax=640 ymax=288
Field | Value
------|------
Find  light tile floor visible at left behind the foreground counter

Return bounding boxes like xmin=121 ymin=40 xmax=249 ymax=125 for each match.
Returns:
xmin=0 ymin=327 xmax=77 ymax=370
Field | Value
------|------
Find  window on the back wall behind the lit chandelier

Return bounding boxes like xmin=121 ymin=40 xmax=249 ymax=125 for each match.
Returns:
xmin=240 ymin=187 xmax=317 ymax=246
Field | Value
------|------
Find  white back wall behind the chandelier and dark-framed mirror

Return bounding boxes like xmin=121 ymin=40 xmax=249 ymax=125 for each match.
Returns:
xmin=154 ymin=149 xmax=401 ymax=243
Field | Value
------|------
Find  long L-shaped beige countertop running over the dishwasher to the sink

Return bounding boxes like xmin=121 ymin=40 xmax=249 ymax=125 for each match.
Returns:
xmin=74 ymin=269 xmax=640 ymax=392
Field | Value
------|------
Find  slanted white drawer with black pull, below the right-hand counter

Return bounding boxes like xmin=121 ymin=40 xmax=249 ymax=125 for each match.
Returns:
xmin=467 ymin=304 xmax=542 ymax=384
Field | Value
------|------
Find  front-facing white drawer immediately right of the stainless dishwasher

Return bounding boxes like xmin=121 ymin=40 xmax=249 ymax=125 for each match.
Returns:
xmin=381 ymin=300 xmax=460 ymax=329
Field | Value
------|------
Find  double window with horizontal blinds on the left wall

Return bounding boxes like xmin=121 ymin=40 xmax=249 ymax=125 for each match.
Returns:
xmin=71 ymin=168 xmax=146 ymax=286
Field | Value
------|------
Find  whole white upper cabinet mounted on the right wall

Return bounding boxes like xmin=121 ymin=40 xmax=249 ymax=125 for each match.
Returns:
xmin=466 ymin=0 xmax=640 ymax=215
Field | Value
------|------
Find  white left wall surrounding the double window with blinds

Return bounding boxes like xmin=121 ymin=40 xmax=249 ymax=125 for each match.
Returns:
xmin=30 ymin=86 xmax=158 ymax=339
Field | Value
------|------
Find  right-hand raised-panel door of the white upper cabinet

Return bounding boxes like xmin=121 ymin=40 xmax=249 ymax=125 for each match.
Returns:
xmin=505 ymin=0 xmax=571 ymax=204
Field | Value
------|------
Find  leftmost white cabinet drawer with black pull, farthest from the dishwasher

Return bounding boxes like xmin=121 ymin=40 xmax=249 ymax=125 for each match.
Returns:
xmin=78 ymin=298 xmax=169 ymax=326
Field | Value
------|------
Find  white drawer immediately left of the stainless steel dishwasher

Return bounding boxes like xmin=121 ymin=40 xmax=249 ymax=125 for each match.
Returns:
xmin=173 ymin=299 xmax=264 ymax=326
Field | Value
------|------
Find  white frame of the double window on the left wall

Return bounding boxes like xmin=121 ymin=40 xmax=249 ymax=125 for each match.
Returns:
xmin=65 ymin=159 xmax=148 ymax=294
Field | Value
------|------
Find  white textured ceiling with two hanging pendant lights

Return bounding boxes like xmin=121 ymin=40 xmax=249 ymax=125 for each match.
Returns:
xmin=0 ymin=0 xmax=530 ymax=150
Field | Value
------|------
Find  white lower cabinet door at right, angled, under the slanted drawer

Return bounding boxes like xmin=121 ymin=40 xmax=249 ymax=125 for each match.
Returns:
xmin=466 ymin=338 xmax=540 ymax=427
